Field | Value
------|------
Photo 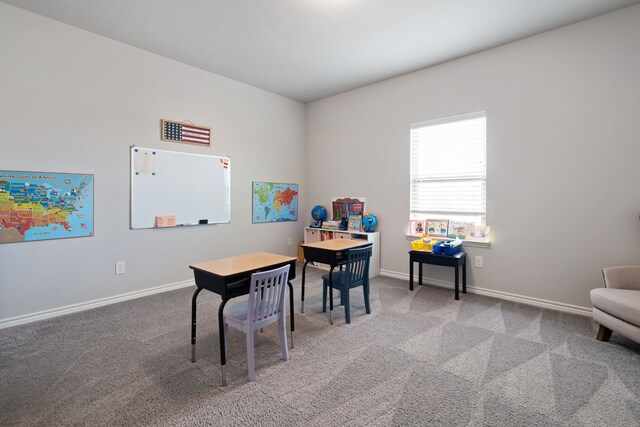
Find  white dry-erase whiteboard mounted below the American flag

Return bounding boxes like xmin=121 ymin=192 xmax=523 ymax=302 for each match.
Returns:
xmin=131 ymin=146 xmax=231 ymax=229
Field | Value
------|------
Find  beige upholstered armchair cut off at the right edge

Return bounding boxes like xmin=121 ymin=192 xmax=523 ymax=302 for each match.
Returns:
xmin=591 ymin=265 xmax=640 ymax=343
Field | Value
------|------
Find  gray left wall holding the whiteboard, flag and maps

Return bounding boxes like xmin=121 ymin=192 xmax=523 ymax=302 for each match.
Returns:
xmin=0 ymin=3 xmax=308 ymax=325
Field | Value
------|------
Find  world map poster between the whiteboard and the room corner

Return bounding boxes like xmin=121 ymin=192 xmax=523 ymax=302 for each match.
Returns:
xmin=253 ymin=182 xmax=298 ymax=224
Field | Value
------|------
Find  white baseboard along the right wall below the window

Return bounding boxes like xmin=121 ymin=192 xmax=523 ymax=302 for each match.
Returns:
xmin=380 ymin=270 xmax=591 ymax=317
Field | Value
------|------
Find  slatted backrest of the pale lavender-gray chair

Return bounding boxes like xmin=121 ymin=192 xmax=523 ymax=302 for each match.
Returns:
xmin=247 ymin=264 xmax=290 ymax=324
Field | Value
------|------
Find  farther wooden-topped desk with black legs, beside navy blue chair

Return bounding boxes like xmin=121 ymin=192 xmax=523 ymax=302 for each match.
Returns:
xmin=300 ymin=239 xmax=371 ymax=325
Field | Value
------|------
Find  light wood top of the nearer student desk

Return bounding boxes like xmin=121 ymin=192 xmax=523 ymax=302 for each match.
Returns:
xmin=189 ymin=252 xmax=296 ymax=277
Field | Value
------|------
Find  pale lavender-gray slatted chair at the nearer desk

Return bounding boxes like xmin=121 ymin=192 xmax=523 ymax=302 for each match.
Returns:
xmin=223 ymin=265 xmax=289 ymax=381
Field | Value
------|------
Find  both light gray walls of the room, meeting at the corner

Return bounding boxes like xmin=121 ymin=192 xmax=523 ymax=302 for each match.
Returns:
xmin=0 ymin=3 xmax=640 ymax=326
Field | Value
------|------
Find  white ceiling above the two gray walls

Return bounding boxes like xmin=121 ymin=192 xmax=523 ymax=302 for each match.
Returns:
xmin=2 ymin=0 xmax=640 ymax=102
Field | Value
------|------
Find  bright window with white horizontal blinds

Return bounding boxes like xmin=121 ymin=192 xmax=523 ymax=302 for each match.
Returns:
xmin=410 ymin=112 xmax=487 ymax=225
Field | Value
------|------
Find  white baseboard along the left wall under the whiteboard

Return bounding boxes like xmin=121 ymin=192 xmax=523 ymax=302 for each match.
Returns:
xmin=0 ymin=280 xmax=196 ymax=329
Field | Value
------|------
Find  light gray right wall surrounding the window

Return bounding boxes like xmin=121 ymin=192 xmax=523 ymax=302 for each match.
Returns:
xmin=307 ymin=6 xmax=640 ymax=311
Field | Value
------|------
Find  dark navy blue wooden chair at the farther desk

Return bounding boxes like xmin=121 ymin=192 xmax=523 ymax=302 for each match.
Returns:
xmin=322 ymin=246 xmax=372 ymax=323
